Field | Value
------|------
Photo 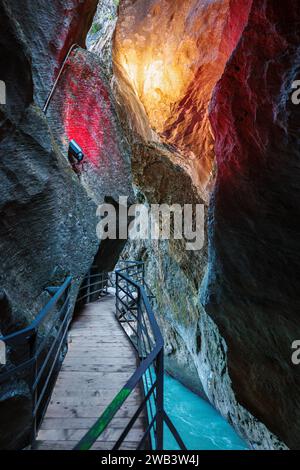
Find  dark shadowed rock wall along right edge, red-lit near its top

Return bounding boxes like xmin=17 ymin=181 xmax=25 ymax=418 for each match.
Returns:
xmin=202 ymin=0 xmax=300 ymax=449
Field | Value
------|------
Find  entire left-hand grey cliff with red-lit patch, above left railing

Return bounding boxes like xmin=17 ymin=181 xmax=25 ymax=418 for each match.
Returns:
xmin=0 ymin=0 xmax=131 ymax=449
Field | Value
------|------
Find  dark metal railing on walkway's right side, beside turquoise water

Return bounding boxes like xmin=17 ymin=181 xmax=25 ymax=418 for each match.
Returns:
xmin=75 ymin=262 xmax=186 ymax=450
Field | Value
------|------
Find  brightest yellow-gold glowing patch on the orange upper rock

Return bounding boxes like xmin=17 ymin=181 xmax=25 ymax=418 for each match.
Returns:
xmin=114 ymin=18 xmax=197 ymax=132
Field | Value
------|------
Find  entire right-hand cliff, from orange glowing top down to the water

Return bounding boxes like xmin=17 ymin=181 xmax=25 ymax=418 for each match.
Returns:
xmin=113 ymin=0 xmax=300 ymax=449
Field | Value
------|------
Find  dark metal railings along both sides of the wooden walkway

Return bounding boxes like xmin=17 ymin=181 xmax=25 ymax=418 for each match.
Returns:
xmin=0 ymin=262 xmax=186 ymax=450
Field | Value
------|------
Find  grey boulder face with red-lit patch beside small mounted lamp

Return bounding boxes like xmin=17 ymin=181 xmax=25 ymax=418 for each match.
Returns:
xmin=47 ymin=48 xmax=132 ymax=204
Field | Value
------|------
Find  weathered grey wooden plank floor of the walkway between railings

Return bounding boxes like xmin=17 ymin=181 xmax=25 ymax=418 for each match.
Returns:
xmin=35 ymin=293 xmax=145 ymax=450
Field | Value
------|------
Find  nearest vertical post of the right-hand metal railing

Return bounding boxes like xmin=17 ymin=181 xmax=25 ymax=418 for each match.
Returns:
xmin=156 ymin=347 xmax=164 ymax=450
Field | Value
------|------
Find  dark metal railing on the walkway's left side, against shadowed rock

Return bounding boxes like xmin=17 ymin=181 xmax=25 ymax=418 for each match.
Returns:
xmin=0 ymin=277 xmax=72 ymax=443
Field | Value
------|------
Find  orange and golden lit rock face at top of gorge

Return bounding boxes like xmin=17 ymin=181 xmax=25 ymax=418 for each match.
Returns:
xmin=114 ymin=0 xmax=251 ymax=192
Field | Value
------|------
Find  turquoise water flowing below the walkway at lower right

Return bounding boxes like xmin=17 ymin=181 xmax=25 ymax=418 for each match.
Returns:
xmin=165 ymin=375 xmax=248 ymax=450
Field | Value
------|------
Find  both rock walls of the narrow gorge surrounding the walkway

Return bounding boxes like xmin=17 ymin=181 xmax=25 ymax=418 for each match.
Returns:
xmin=0 ymin=0 xmax=300 ymax=450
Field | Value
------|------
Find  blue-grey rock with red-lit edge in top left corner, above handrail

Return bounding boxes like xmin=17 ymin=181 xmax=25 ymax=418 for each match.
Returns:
xmin=1 ymin=0 xmax=98 ymax=107
